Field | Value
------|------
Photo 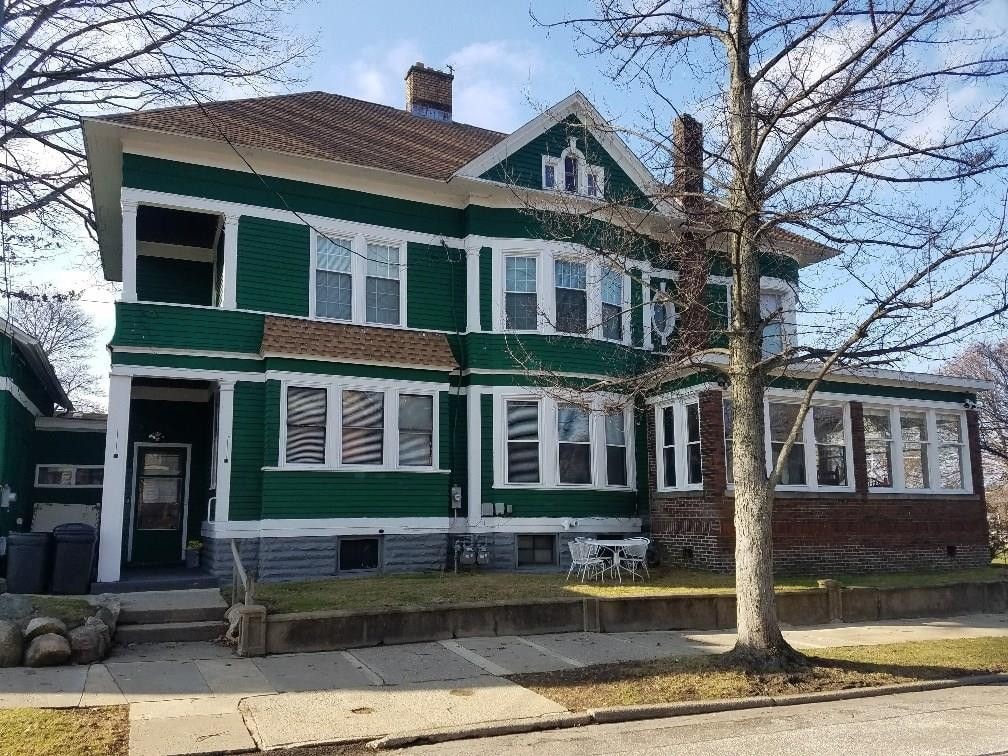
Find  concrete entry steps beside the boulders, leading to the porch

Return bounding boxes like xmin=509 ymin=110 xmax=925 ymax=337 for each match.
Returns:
xmin=116 ymin=589 xmax=228 ymax=644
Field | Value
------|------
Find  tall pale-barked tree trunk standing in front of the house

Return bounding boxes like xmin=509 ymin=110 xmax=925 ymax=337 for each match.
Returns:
xmin=725 ymin=0 xmax=802 ymax=668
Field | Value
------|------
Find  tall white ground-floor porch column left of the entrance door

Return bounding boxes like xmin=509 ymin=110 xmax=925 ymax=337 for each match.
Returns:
xmin=98 ymin=374 xmax=133 ymax=583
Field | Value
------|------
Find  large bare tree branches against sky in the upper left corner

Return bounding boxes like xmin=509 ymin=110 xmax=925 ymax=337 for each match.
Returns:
xmin=0 ymin=0 xmax=311 ymax=245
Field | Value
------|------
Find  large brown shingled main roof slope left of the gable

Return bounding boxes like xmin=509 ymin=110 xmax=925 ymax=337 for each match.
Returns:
xmin=101 ymin=92 xmax=506 ymax=180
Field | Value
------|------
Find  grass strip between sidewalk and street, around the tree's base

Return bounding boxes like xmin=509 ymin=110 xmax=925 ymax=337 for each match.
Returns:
xmin=510 ymin=637 xmax=1008 ymax=712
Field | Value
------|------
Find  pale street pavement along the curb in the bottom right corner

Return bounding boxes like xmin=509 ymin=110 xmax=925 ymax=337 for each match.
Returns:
xmin=398 ymin=685 xmax=1008 ymax=756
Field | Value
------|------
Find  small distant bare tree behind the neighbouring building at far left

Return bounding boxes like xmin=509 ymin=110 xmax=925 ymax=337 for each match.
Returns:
xmin=10 ymin=286 xmax=104 ymax=410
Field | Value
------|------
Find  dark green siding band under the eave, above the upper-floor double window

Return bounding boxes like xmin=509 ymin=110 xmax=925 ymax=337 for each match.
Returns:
xmin=123 ymin=153 xmax=464 ymax=236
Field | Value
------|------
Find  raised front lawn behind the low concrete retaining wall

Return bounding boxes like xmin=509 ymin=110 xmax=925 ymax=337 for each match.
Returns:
xmin=249 ymin=566 xmax=1008 ymax=614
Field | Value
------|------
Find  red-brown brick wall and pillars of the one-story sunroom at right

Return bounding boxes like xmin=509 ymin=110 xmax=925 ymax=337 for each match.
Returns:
xmin=647 ymin=391 xmax=990 ymax=576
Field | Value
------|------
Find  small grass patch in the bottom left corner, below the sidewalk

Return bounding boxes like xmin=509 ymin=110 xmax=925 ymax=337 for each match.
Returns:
xmin=0 ymin=706 xmax=129 ymax=756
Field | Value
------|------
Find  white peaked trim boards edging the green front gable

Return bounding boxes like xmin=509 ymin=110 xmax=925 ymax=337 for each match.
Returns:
xmin=450 ymin=91 xmax=665 ymax=215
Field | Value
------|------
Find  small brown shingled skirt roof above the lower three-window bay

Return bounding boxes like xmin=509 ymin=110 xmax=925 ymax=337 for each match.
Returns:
xmin=262 ymin=316 xmax=459 ymax=370
